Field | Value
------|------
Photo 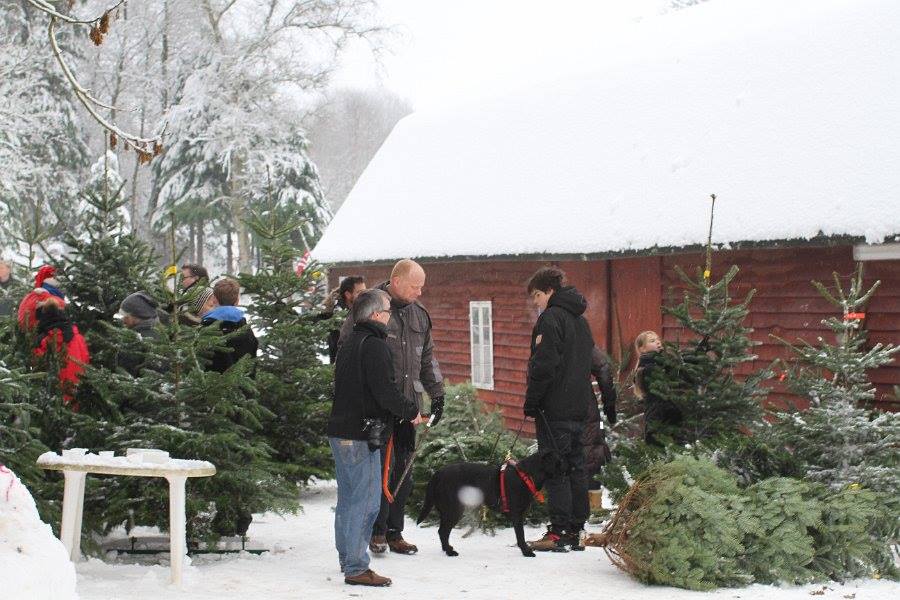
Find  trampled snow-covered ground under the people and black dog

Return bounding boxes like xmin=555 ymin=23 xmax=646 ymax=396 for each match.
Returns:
xmin=72 ymin=482 xmax=900 ymax=600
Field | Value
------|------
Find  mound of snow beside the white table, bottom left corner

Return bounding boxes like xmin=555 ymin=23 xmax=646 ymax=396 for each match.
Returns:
xmin=0 ymin=466 xmax=78 ymax=600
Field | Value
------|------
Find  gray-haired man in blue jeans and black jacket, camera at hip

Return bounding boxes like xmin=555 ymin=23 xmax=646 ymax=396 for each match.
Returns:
xmin=327 ymin=289 xmax=423 ymax=586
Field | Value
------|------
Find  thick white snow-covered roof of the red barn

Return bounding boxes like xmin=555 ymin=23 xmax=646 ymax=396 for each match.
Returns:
xmin=313 ymin=0 xmax=900 ymax=262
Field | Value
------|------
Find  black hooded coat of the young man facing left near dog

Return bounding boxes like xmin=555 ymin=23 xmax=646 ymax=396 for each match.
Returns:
xmin=525 ymin=287 xmax=596 ymax=421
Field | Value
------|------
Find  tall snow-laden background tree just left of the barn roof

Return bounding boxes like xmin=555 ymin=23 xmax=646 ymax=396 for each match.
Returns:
xmin=151 ymin=39 xmax=331 ymax=272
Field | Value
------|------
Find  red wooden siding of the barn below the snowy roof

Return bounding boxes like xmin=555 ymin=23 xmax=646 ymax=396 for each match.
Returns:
xmin=330 ymin=246 xmax=900 ymax=434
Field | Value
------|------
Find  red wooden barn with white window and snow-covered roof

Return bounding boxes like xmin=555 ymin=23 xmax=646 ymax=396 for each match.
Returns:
xmin=313 ymin=5 xmax=900 ymax=432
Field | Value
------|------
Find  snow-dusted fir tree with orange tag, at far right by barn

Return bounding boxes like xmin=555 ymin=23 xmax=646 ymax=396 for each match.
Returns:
xmin=774 ymin=266 xmax=900 ymax=497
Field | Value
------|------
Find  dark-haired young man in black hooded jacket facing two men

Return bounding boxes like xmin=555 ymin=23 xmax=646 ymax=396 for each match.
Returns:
xmin=524 ymin=267 xmax=596 ymax=552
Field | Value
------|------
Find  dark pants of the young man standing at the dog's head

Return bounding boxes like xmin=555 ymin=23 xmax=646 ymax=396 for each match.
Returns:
xmin=536 ymin=417 xmax=590 ymax=533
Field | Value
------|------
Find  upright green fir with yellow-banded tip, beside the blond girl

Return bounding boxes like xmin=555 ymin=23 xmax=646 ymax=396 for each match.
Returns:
xmin=647 ymin=266 xmax=773 ymax=443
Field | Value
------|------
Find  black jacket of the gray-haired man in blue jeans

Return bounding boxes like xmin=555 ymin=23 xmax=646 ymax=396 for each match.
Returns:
xmin=327 ymin=321 xmax=419 ymax=440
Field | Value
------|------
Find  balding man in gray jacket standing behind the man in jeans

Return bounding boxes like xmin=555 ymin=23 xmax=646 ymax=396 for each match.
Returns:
xmin=341 ymin=258 xmax=444 ymax=554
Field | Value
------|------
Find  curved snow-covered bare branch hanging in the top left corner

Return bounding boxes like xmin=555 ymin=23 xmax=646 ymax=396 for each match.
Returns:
xmin=26 ymin=0 xmax=162 ymax=164
